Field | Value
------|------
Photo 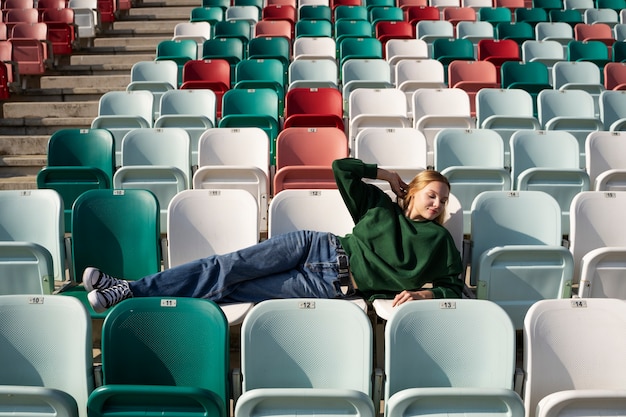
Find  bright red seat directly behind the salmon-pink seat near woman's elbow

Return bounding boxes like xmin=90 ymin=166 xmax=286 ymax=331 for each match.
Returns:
xmin=283 ymin=88 xmax=344 ymax=131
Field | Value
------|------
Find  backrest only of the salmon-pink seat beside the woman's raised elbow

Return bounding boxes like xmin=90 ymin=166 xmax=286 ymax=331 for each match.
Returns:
xmin=276 ymin=127 xmax=349 ymax=170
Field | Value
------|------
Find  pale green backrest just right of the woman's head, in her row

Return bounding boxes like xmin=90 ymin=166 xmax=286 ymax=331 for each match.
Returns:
xmin=471 ymin=191 xmax=563 ymax=265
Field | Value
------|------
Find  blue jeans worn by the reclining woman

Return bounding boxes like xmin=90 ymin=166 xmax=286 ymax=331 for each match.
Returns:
xmin=130 ymin=230 xmax=349 ymax=303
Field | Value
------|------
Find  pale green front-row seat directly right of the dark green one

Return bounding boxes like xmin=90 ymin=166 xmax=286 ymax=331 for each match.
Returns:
xmin=235 ymin=299 xmax=380 ymax=417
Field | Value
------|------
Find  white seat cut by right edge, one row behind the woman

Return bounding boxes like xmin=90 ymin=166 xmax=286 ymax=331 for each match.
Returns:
xmin=585 ymin=131 xmax=626 ymax=191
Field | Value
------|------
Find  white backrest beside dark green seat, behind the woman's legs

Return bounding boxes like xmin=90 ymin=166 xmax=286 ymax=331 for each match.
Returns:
xmin=167 ymin=189 xmax=259 ymax=267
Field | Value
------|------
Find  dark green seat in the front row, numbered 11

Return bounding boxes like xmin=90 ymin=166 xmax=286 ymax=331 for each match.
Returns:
xmin=87 ymin=297 xmax=230 ymax=417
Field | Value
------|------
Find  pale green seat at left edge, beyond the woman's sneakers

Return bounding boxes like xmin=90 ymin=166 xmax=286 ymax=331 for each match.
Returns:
xmin=0 ymin=190 xmax=66 ymax=294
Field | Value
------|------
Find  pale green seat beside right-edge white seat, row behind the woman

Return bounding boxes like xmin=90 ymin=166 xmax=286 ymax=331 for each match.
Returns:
xmin=511 ymin=130 xmax=590 ymax=235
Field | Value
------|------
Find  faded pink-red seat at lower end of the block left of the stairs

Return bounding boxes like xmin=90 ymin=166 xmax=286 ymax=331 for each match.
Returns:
xmin=9 ymin=22 xmax=53 ymax=74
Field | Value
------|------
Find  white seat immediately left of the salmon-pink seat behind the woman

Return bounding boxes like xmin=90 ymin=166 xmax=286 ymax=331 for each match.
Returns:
xmin=192 ymin=127 xmax=270 ymax=233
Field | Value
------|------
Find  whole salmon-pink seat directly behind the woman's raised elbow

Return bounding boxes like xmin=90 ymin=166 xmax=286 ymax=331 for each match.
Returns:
xmin=274 ymin=127 xmax=349 ymax=194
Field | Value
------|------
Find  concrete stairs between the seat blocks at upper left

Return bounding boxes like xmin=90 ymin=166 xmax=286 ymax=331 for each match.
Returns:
xmin=0 ymin=0 xmax=195 ymax=190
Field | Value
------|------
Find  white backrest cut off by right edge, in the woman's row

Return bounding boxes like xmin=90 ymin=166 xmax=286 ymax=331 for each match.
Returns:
xmin=569 ymin=190 xmax=626 ymax=283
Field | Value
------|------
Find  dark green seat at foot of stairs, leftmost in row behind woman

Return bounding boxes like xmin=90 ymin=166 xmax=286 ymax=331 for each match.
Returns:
xmin=37 ymin=128 xmax=115 ymax=233
